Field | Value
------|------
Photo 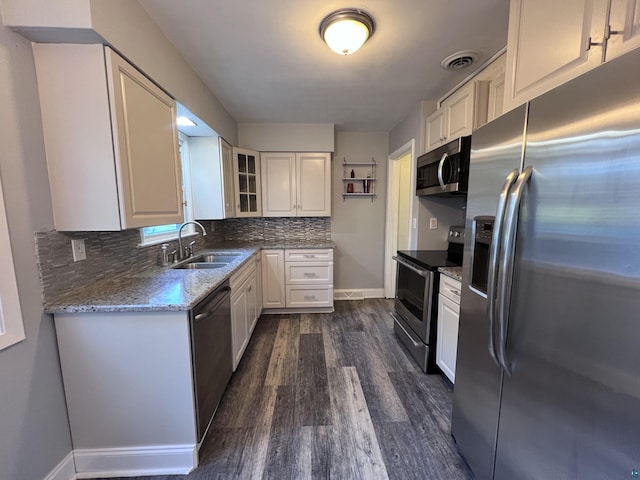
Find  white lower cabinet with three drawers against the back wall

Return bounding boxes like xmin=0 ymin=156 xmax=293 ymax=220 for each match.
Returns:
xmin=262 ymin=249 xmax=333 ymax=313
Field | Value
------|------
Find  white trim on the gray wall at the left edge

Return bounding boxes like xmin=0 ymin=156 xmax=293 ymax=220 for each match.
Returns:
xmin=0 ymin=174 xmax=25 ymax=350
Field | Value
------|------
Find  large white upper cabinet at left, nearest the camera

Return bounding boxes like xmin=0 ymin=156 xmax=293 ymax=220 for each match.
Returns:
xmin=33 ymin=44 xmax=184 ymax=231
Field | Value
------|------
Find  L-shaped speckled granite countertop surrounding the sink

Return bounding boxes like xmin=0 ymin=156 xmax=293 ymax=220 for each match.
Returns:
xmin=44 ymin=241 xmax=334 ymax=314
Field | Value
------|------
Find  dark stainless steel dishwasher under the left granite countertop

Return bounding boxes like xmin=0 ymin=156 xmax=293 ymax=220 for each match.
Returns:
xmin=190 ymin=282 xmax=233 ymax=443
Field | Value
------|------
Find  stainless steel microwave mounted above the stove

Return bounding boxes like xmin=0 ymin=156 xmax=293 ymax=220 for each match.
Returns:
xmin=416 ymin=135 xmax=471 ymax=196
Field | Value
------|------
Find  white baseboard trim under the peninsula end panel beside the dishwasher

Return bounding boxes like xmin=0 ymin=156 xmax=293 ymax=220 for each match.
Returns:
xmin=73 ymin=444 xmax=198 ymax=479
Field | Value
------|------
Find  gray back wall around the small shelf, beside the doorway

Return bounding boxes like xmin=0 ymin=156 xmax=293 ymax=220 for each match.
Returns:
xmin=331 ymin=132 xmax=389 ymax=290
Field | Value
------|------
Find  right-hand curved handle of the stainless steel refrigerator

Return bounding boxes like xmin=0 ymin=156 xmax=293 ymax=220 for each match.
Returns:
xmin=497 ymin=166 xmax=533 ymax=375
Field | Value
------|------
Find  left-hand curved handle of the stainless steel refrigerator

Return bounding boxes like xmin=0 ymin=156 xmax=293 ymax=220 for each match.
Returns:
xmin=487 ymin=168 xmax=520 ymax=367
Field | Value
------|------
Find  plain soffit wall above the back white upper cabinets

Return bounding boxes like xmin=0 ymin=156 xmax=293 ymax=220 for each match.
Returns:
xmin=238 ymin=123 xmax=335 ymax=152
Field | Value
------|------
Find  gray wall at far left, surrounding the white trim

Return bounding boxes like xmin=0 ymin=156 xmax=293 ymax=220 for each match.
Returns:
xmin=0 ymin=20 xmax=71 ymax=480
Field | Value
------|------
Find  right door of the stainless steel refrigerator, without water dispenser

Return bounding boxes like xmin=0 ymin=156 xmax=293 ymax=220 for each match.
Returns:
xmin=498 ymin=50 xmax=640 ymax=480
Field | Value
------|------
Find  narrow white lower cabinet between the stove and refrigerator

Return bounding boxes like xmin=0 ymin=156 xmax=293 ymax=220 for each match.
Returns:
xmin=436 ymin=275 xmax=462 ymax=383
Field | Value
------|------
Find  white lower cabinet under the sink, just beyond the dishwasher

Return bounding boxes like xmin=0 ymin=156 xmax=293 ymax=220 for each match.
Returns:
xmin=229 ymin=253 xmax=260 ymax=371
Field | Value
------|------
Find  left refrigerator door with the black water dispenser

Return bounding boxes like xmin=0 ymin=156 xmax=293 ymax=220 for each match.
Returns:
xmin=451 ymin=106 xmax=526 ymax=479
